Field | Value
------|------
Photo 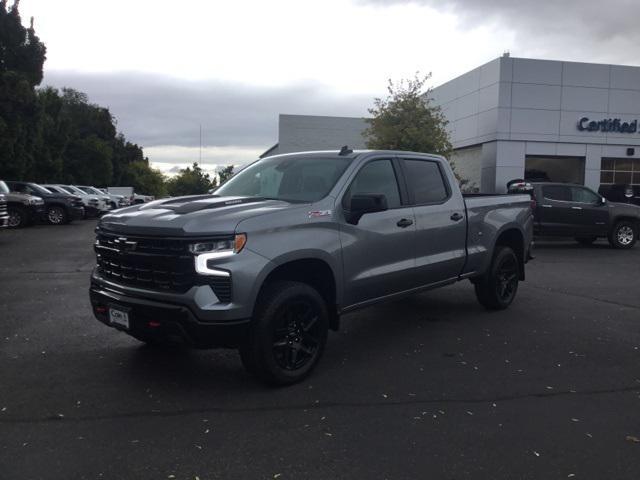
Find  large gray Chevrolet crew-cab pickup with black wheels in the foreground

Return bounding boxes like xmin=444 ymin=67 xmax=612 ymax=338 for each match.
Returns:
xmin=90 ymin=148 xmax=533 ymax=385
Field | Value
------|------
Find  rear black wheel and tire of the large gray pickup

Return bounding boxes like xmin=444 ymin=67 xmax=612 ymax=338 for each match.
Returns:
xmin=475 ymin=246 xmax=520 ymax=310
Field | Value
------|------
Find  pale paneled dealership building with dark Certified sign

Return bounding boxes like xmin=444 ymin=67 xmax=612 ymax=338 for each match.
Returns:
xmin=263 ymin=55 xmax=640 ymax=193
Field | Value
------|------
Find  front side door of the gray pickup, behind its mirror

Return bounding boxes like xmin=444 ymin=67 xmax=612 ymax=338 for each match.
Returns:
xmin=340 ymin=159 xmax=416 ymax=306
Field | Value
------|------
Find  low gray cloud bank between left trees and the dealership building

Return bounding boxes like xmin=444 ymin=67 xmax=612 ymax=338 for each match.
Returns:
xmin=43 ymin=71 xmax=372 ymax=149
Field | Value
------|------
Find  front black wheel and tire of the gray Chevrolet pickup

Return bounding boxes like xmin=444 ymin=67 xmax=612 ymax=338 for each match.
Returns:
xmin=240 ymin=281 xmax=329 ymax=385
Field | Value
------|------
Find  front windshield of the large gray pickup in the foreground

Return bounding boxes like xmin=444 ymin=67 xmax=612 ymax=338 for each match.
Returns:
xmin=215 ymin=156 xmax=351 ymax=202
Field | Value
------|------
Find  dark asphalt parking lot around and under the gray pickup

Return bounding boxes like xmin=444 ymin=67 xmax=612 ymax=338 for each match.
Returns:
xmin=0 ymin=221 xmax=640 ymax=480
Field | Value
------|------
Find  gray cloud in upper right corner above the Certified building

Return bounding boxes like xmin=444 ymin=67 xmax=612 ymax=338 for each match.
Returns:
xmin=358 ymin=0 xmax=640 ymax=63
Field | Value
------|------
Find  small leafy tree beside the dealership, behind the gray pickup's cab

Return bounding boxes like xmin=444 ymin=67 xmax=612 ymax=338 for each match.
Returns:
xmin=364 ymin=74 xmax=466 ymax=184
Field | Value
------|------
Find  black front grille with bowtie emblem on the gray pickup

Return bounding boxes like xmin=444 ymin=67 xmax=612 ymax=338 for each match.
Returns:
xmin=95 ymin=231 xmax=231 ymax=303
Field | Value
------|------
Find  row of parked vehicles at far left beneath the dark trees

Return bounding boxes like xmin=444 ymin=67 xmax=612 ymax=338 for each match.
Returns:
xmin=0 ymin=180 xmax=149 ymax=228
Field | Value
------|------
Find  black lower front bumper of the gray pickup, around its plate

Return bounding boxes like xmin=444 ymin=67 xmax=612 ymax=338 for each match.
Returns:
xmin=89 ymin=279 xmax=249 ymax=348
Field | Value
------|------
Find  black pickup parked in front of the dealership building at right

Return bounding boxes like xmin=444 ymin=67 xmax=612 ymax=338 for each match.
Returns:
xmin=531 ymin=182 xmax=640 ymax=248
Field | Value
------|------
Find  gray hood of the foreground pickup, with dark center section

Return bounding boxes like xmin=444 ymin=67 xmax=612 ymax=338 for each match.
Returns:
xmin=99 ymin=195 xmax=292 ymax=236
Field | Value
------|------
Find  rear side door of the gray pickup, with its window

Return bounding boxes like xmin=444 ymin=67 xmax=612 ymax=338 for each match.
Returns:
xmin=400 ymin=157 xmax=467 ymax=286
